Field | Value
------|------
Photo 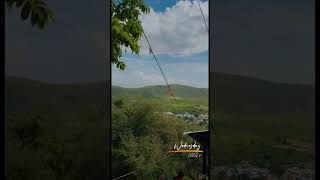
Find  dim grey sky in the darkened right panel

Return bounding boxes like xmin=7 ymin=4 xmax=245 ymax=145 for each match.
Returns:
xmin=210 ymin=0 xmax=315 ymax=84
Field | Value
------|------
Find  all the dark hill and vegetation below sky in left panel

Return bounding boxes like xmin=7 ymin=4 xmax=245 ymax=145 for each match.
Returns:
xmin=5 ymin=78 xmax=110 ymax=180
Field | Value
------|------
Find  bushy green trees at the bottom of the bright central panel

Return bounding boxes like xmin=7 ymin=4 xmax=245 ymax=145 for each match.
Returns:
xmin=112 ymin=98 xmax=202 ymax=179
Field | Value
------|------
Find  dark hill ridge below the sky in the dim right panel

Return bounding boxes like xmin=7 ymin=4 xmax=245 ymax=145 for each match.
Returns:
xmin=210 ymin=73 xmax=315 ymax=115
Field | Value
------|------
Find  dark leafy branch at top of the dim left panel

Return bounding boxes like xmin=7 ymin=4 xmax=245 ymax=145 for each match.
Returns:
xmin=5 ymin=0 xmax=54 ymax=30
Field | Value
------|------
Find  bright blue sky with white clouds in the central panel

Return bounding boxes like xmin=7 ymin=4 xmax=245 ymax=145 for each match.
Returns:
xmin=112 ymin=0 xmax=209 ymax=88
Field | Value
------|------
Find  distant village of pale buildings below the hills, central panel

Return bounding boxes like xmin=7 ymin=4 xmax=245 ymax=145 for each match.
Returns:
xmin=163 ymin=112 xmax=208 ymax=124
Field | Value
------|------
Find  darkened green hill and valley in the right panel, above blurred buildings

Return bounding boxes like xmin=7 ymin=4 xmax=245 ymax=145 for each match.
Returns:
xmin=210 ymin=73 xmax=315 ymax=176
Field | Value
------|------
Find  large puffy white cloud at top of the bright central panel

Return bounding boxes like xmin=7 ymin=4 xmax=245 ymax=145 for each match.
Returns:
xmin=140 ymin=0 xmax=208 ymax=56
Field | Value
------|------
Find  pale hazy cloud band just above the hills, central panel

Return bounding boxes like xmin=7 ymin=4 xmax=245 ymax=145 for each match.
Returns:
xmin=112 ymin=58 xmax=208 ymax=87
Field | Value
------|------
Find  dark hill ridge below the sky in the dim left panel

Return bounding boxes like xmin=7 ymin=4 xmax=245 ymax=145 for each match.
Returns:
xmin=5 ymin=77 xmax=110 ymax=119
